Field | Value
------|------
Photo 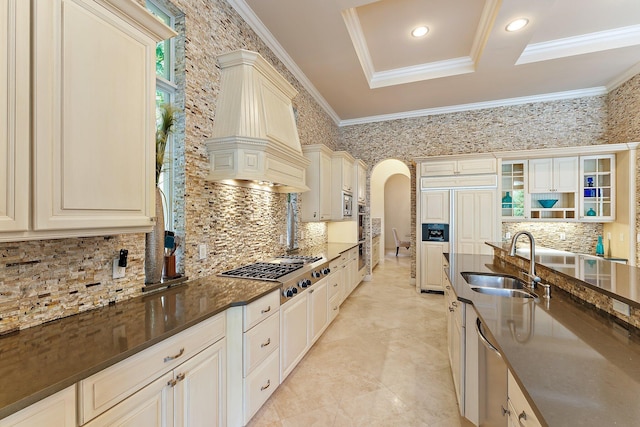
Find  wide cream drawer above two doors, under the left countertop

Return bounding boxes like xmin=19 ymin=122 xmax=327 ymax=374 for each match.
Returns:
xmin=78 ymin=313 xmax=225 ymax=424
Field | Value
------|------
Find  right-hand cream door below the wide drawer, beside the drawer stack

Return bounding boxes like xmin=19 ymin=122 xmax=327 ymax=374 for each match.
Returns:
xmin=173 ymin=339 xmax=226 ymax=427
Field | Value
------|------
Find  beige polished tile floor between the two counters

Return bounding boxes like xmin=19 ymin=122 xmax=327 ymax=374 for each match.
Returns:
xmin=249 ymin=250 xmax=471 ymax=427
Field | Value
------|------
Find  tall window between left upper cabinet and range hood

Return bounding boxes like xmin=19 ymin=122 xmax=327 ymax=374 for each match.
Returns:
xmin=146 ymin=0 xmax=178 ymax=230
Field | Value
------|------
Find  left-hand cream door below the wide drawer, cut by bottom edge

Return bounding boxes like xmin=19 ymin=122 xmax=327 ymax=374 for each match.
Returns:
xmin=84 ymin=372 xmax=173 ymax=427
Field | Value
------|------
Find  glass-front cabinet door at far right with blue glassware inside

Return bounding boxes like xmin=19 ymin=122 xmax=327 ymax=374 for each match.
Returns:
xmin=579 ymin=154 xmax=616 ymax=222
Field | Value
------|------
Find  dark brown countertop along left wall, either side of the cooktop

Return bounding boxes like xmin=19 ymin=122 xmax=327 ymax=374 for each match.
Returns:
xmin=0 ymin=243 xmax=357 ymax=419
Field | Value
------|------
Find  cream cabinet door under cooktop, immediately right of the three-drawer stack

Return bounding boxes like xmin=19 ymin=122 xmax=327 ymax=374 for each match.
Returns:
xmin=280 ymin=293 xmax=308 ymax=382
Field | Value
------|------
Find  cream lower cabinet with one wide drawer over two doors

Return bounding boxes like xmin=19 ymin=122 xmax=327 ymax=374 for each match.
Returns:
xmin=78 ymin=314 xmax=226 ymax=427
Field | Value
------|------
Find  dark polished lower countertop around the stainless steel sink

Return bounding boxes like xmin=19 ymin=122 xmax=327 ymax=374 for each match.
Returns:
xmin=447 ymin=254 xmax=640 ymax=427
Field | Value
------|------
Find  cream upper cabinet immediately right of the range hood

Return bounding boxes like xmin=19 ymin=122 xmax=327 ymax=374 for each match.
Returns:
xmin=301 ymin=144 xmax=332 ymax=222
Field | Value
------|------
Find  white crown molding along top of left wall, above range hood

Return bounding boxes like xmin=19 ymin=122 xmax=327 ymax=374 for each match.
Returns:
xmin=227 ymin=0 xmax=340 ymax=124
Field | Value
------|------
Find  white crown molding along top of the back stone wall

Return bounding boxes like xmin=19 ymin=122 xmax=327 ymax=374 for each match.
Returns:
xmin=340 ymin=86 xmax=608 ymax=127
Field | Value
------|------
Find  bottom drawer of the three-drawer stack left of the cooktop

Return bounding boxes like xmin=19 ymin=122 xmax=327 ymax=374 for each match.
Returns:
xmin=244 ymin=351 xmax=280 ymax=424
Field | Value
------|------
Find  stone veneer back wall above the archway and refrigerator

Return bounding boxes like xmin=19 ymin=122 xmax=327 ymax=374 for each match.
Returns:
xmin=340 ymin=96 xmax=607 ymax=278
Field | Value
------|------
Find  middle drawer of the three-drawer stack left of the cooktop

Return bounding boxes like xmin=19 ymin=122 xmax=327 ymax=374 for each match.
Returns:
xmin=243 ymin=312 xmax=280 ymax=377
